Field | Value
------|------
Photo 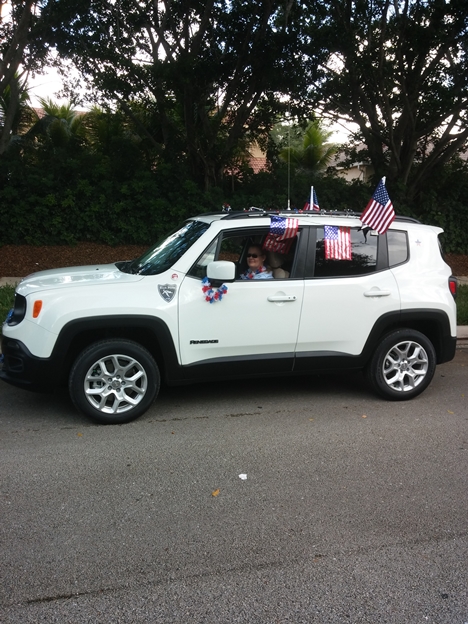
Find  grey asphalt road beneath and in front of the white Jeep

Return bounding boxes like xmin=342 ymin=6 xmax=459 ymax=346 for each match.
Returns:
xmin=0 ymin=350 xmax=468 ymax=624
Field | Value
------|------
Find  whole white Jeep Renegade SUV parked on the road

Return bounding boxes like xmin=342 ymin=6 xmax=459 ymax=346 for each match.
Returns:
xmin=0 ymin=210 xmax=456 ymax=423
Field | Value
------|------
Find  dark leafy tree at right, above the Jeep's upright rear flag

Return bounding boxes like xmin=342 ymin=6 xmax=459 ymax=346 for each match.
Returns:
xmin=311 ymin=0 xmax=468 ymax=200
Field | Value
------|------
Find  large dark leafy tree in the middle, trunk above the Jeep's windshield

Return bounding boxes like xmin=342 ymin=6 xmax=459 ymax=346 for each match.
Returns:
xmin=49 ymin=0 xmax=326 ymax=188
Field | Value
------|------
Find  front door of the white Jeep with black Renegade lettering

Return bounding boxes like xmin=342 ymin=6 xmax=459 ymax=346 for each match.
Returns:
xmin=179 ymin=232 xmax=304 ymax=375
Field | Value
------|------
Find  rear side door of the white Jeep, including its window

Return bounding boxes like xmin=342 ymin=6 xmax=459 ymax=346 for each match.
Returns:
xmin=295 ymin=227 xmax=400 ymax=370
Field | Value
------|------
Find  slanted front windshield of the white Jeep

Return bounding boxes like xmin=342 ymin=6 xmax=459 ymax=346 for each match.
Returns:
xmin=119 ymin=221 xmax=210 ymax=275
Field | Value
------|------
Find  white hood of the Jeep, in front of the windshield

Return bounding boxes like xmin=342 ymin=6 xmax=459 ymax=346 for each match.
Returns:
xmin=16 ymin=264 xmax=144 ymax=296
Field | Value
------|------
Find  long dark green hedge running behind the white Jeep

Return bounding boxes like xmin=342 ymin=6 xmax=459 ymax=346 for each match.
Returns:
xmin=0 ymin=139 xmax=468 ymax=254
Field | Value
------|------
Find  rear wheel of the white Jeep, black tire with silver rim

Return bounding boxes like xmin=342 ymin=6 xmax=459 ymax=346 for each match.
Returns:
xmin=366 ymin=329 xmax=437 ymax=401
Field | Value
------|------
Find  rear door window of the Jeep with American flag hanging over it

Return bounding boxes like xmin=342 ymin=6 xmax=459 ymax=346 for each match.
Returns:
xmin=314 ymin=226 xmax=379 ymax=277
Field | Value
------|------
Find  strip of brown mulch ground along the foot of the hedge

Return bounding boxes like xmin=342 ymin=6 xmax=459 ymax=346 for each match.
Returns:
xmin=0 ymin=243 xmax=468 ymax=277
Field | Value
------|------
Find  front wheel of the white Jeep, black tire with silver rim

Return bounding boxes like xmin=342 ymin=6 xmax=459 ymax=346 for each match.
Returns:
xmin=68 ymin=339 xmax=161 ymax=425
